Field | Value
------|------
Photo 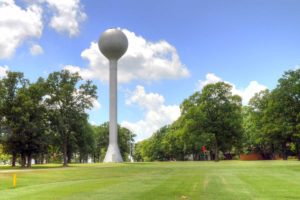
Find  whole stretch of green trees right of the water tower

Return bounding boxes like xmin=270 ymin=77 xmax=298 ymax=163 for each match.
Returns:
xmin=134 ymin=69 xmax=300 ymax=161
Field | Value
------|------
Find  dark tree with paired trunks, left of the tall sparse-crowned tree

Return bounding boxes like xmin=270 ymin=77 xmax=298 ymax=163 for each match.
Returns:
xmin=12 ymin=78 xmax=49 ymax=167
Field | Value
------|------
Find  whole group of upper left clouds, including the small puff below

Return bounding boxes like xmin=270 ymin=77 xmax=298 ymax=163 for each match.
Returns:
xmin=0 ymin=0 xmax=87 ymax=59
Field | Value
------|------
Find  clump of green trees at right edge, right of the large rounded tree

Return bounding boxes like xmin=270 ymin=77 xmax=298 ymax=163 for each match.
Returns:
xmin=244 ymin=69 xmax=300 ymax=159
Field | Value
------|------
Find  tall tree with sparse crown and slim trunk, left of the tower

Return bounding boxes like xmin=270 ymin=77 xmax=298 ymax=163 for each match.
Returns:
xmin=45 ymin=70 xmax=97 ymax=166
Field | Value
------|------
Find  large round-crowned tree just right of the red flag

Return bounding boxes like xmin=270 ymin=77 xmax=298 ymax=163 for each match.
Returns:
xmin=199 ymin=82 xmax=242 ymax=161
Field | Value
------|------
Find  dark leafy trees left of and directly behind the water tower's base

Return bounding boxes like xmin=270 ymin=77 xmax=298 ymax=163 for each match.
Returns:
xmin=0 ymin=70 xmax=134 ymax=167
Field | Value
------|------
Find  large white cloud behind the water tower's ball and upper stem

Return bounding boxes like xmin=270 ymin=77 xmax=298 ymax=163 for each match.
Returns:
xmin=65 ymin=29 xmax=189 ymax=83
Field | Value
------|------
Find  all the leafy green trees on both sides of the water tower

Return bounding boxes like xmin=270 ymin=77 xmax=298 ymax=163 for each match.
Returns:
xmin=0 ymin=69 xmax=300 ymax=164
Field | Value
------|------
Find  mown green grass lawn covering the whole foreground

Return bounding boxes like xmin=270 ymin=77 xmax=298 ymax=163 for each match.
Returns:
xmin=0 ymin=161 xmax=300 ymax=200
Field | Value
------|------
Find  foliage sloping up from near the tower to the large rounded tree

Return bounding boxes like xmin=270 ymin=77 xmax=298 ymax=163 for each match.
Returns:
xmin=136 ymin=82 xmax=242 ymax=161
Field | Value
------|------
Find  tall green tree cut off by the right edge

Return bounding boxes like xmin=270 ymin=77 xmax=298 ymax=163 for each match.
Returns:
xmin=267 ymin=69 xmax=300 ymax=160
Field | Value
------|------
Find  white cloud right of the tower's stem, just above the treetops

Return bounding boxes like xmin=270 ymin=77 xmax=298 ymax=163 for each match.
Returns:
xmin=121 ymin=86 xmax=180 ymax=141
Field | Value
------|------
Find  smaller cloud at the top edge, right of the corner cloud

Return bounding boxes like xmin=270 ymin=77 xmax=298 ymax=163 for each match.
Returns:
xmin=42 ymin=0 xmax=87 ymax=36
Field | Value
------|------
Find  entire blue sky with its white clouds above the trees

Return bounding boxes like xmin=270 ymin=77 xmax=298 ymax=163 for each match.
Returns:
xmin=0 ymin=0 xmax=300 ymax=140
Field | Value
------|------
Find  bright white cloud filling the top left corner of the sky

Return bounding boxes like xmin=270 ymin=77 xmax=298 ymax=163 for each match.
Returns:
xmin=0 ymin=0 xmax=43 ymax=59
